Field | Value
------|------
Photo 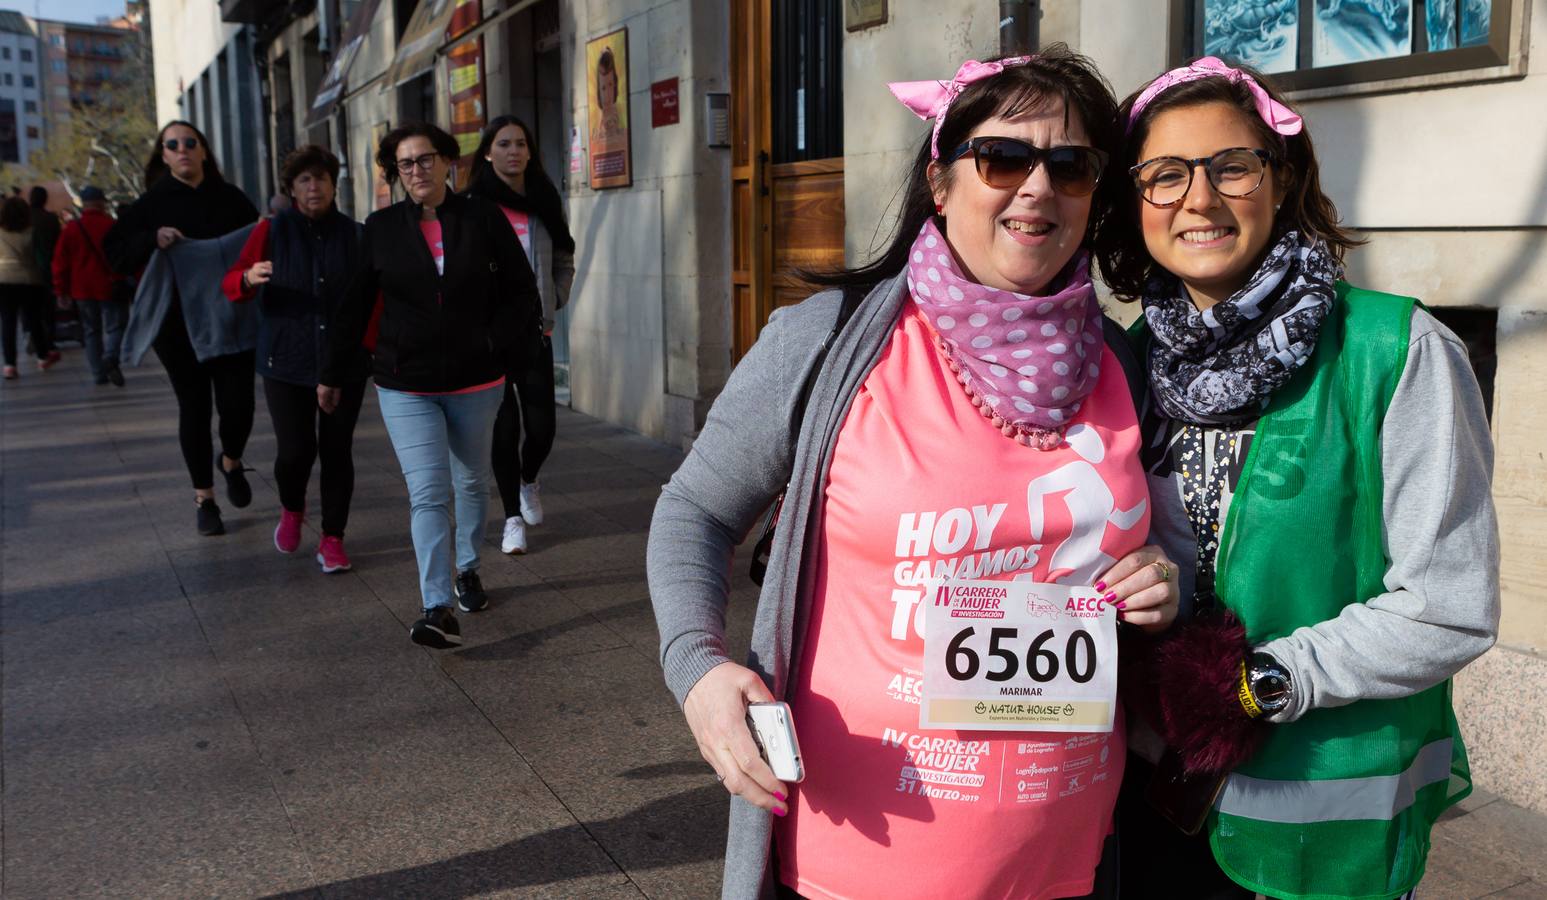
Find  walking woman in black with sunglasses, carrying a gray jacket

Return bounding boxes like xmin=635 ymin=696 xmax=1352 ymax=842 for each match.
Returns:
xmin=102 ymin=121 xmax=258 ymax=535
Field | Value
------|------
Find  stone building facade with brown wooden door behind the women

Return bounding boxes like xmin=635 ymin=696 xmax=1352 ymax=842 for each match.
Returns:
xmin=152 ymin=0 xmax=1547 ymax=812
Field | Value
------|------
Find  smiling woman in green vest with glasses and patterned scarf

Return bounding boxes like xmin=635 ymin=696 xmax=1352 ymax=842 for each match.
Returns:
xmin=1097 ymin=57 xmax=1499 ymax=898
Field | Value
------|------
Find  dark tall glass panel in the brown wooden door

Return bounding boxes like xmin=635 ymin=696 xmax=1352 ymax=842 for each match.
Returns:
xmin=770 ymin=0 xmax=843 ymax=162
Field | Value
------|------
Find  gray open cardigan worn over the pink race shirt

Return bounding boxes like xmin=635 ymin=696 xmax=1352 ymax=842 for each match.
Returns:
xmin=647 ymin=275 xmax=907 ymax=898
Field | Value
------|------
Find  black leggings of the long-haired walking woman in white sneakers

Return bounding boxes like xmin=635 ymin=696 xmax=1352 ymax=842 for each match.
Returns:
xmin=492 ymin=336 xmax=558 ymax=518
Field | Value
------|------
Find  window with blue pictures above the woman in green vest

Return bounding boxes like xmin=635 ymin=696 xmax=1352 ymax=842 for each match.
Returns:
xmin=1171 ymin=0 xmax=1518 ymax=90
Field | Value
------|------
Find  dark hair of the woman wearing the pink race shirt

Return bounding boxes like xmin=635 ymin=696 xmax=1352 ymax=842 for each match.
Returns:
xmin=801 ymin=43 xmax=1120 ymax=286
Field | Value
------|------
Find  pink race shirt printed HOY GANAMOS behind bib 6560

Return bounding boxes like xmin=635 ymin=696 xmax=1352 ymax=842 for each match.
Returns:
xmin=775 ymin=302 xmax=1149 ymax=900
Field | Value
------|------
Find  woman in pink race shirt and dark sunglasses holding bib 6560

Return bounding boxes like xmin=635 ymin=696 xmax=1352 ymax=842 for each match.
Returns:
xmin=648 ymin=46 xmax=1177 ymax=898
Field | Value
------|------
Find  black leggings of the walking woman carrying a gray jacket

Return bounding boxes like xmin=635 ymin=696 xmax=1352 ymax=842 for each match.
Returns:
xmin=152 ymin=300 xmax=257 ymax=490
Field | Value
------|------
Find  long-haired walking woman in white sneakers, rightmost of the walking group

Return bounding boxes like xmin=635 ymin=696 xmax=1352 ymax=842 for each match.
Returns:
xmin=467 ymin=116 xmax=575 ymax=554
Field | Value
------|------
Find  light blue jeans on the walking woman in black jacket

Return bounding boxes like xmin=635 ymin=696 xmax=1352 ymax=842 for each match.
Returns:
xmin=376 ymin=385 xmax=504 ymax=609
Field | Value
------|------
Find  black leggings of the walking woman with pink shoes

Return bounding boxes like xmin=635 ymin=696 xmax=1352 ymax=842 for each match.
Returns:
xmin=263 ymin=377 xmax=365 ymax=538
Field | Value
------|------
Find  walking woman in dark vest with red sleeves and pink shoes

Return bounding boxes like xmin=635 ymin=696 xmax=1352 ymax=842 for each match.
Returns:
xmin=223 ymin=144 xmax=370 ymax=572
